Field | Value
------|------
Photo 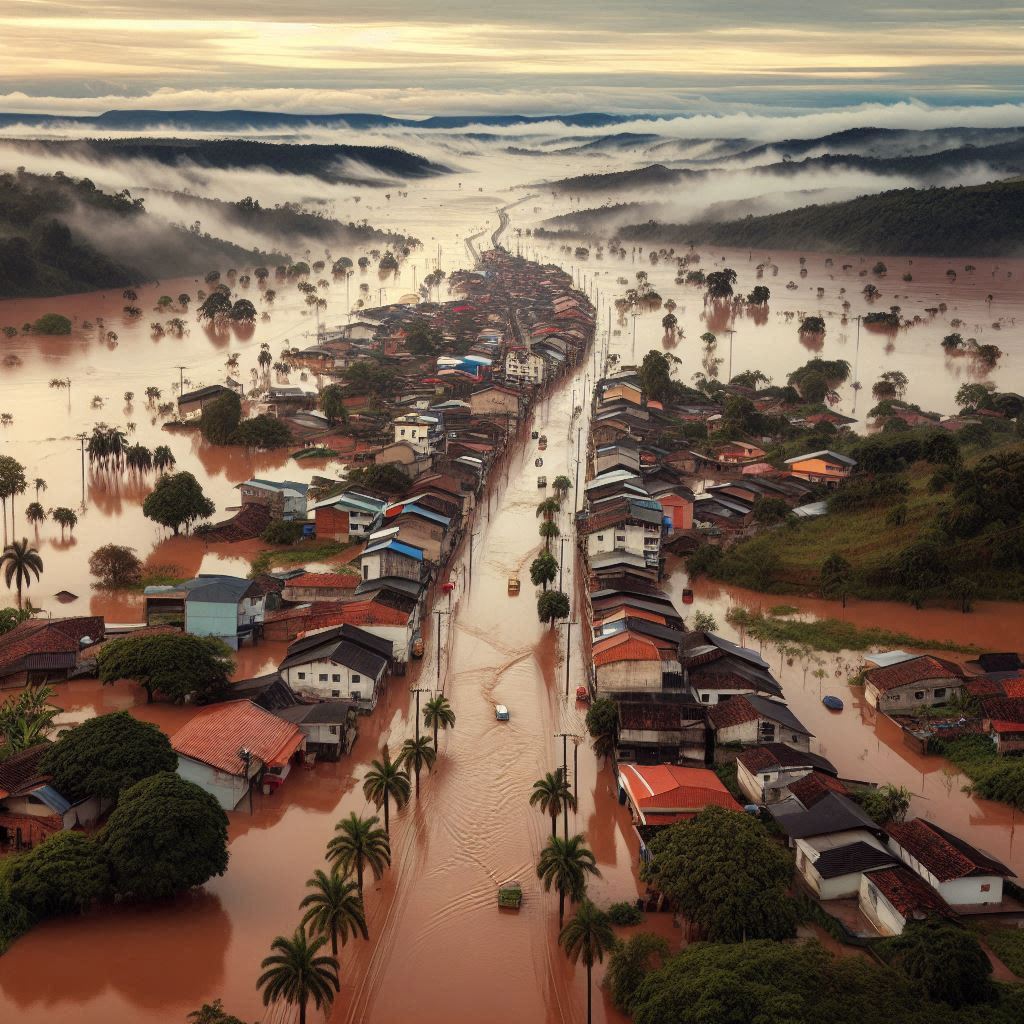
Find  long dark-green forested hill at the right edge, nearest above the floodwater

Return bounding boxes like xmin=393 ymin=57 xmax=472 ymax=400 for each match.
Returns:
xmin=617 ymin=178 xmax=1024 ymax=256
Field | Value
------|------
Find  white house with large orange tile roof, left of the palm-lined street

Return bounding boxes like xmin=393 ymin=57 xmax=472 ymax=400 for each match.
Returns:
xmin=171 ymin=700 xmax=306 ymax=811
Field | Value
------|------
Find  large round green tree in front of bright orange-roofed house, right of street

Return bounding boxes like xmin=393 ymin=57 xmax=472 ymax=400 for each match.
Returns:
xmin=641 ymin=806 xmax=797 ymax=942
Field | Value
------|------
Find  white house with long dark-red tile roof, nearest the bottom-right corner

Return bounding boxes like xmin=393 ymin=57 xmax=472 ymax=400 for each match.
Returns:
xmin=889 ymin=818 xmax=1014 ymax=906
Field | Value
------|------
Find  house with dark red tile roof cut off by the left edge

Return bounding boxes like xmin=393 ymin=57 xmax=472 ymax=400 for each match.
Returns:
xmin=0 ymin=615 xmax=103 ymax=689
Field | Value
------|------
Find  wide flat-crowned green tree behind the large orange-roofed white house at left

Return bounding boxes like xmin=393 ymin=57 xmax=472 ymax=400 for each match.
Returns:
xmin=97 ymin=633 xmax=234 ymax=703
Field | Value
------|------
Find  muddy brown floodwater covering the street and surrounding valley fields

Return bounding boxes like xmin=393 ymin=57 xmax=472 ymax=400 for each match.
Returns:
xmin=0 ymin=190 xmax=1024 ymax=1024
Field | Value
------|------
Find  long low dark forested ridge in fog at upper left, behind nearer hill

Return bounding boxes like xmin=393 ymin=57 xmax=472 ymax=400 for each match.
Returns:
xmin=7 ymin=138 xmax=446 ymax=184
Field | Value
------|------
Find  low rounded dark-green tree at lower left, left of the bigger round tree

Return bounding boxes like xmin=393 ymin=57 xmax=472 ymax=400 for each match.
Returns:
xmin=8 ymin=831 xmax=110 ymax=919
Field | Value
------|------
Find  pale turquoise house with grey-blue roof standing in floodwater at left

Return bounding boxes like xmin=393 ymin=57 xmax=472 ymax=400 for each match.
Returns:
xmin=142 ymin=575 xmax=266 ymax=650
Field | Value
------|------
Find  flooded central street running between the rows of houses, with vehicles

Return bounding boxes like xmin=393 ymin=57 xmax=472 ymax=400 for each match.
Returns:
xmin=333 ymin=331 xmax=636 ymax=1024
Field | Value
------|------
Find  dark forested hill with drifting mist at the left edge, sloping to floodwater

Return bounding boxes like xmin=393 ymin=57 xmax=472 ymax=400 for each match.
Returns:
xmin=0 ymin=172 xmax=281 ymax=298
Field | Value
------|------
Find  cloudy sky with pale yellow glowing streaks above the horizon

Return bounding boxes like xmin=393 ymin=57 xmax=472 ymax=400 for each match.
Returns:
xmin=0 ymin=0 xmax=1024 ymax=115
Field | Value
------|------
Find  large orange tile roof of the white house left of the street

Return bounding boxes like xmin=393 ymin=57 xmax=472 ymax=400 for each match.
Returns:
xmin=171 ymin=700 xmax=305 ymax=775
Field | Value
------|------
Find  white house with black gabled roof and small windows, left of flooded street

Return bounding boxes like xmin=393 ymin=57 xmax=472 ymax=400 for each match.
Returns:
xmin=279 ymin=625 xmax=393 ymax=711
